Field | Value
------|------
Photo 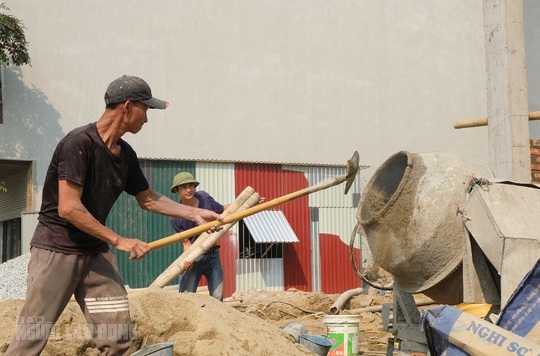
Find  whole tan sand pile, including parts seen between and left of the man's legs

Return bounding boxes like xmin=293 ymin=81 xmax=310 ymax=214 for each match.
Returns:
xmin=0 ymin=289 xmax=313 ymax=356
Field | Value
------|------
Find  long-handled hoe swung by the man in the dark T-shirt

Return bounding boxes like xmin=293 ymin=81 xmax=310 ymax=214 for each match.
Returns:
xmin=148 ymin=151 xmax=360 ymax=251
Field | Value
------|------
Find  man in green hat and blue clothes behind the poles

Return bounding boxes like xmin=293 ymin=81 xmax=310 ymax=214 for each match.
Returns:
xmin=171 ymin=172 xmax=228 ymax=301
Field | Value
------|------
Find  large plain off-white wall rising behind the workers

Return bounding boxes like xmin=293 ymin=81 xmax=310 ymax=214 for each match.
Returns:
xmin=0 ymin=0 xmax=488 ymax=209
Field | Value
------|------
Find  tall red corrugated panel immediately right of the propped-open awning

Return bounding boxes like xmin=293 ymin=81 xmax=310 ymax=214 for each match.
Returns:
xmin=282 ymin=171 xmax=312 ymax=291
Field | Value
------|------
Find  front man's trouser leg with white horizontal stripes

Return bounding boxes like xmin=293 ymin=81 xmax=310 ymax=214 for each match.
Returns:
xmin=75 ymin=251 xmax=134 ymax=355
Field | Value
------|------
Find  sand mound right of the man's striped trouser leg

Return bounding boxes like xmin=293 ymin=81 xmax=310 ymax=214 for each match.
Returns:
xmin=130 ymin=290 xmax=311 ymax=356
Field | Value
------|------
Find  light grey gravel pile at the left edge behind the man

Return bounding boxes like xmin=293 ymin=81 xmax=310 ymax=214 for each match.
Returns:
xmin=0 ymin=253 xmax=30 ymax=300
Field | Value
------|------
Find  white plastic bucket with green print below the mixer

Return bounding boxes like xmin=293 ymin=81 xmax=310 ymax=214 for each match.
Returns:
xmin=323 ymin=315 xmax=360 ymax=356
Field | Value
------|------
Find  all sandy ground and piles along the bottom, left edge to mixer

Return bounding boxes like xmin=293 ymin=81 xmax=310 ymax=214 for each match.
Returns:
xmin=0 ymin=288 xmax=434 ymax=356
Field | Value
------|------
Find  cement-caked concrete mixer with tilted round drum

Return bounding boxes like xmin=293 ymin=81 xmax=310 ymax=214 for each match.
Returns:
xmin=357 ymin=151 xmax=540 ymax=355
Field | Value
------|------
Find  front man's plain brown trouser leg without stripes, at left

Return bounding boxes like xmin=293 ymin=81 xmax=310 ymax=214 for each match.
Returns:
xmin=4 ymin=247 xmax=81 ymax=356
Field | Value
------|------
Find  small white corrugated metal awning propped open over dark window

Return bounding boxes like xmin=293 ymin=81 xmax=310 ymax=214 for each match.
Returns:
xmin=244 ymin=210 xmax=299 ymax=243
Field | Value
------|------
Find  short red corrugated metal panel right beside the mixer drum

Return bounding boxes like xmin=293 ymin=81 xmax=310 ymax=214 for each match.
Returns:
xmin=319 ymin=234 xmax=362 ymax=294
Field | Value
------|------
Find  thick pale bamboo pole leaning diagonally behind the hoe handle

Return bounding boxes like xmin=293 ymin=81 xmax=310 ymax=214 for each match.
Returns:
xmin=150 ymin=187 xmax=261 ymax=288
